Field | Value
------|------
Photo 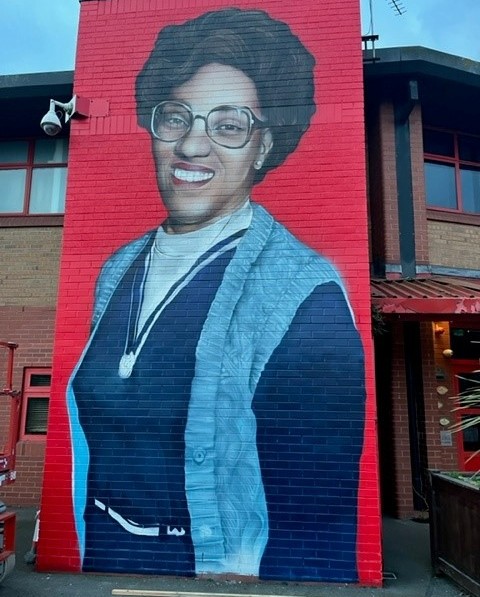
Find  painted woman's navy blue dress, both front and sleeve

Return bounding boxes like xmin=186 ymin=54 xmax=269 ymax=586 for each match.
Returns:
xmin=74 ymin=230 xmax=365 ymax=582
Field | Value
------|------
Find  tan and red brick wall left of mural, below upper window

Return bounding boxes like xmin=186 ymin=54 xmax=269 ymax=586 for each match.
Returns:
xmin=0 ymin=226 xmax=62 ymax=506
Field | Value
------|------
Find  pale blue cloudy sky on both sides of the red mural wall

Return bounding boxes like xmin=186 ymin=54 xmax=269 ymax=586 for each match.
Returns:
xmin=0 ymin=0 xmax=480 ymax=75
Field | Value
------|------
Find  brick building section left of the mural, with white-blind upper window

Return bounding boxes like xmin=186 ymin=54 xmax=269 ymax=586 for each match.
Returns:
xmin=0 ymin=72 xmax=73 ymax=506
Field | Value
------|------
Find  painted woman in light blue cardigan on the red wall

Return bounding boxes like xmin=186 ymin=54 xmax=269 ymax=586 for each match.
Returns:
xmin=68 ymin=9 xmax=365 ymax=581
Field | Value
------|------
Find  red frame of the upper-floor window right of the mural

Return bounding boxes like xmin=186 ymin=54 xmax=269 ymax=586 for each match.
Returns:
xmin=423 ymin=126 xmax=480 ymax=218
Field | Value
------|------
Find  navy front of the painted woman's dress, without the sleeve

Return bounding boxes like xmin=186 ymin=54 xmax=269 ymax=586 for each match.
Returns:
xmin=73 ymin=236 xmax=234 ymax=575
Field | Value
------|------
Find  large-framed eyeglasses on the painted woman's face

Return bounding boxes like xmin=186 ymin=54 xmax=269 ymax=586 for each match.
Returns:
xmin=150 ymin=101 xmax=266 ymax=149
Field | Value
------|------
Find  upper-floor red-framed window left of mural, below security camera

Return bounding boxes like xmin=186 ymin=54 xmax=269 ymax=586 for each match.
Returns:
xmin=0 ymin=139 xmax=68 ymax=216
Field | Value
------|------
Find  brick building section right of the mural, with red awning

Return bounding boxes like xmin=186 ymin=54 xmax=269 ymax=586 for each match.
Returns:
xmin=365 ymin=47 xmax=480 ymax=517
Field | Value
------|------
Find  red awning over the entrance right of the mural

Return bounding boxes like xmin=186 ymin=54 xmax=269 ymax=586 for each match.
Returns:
xmin=371 ymin=276 xmax=480 ymax=315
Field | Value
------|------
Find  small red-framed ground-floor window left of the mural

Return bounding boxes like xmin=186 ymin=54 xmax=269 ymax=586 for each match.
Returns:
xmin=20 ymin=368 xmax=52 ymax=440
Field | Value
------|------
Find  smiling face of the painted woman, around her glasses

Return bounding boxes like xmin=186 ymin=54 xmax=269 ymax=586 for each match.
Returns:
xmin=152 ymin=64 xmax=272 ymax=233
